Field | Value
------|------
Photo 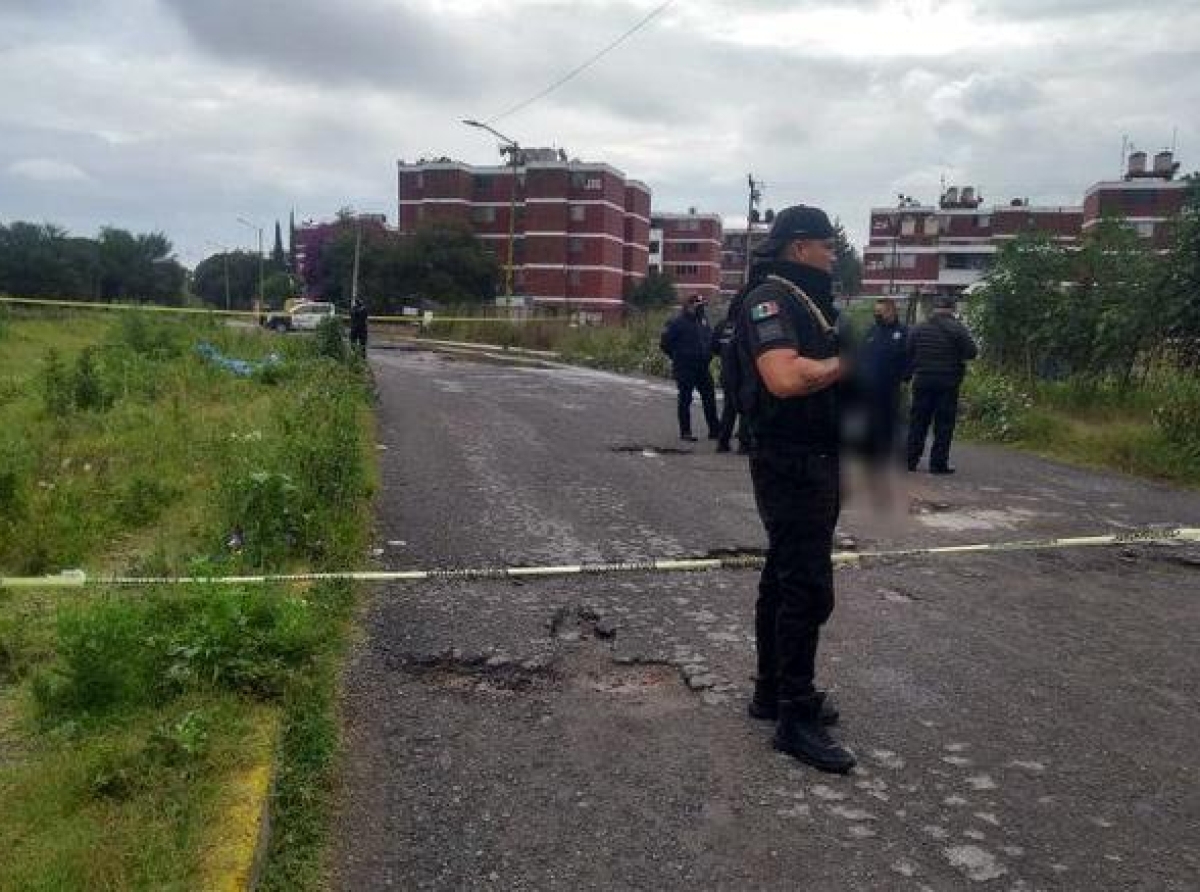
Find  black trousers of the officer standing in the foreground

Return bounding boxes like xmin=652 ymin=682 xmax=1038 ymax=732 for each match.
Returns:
xmin=750 ymin=448 xmax=841 ymax=701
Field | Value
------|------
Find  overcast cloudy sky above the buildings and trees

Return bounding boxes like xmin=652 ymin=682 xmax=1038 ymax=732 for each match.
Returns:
xmin=0 ymin=0 xmax=1200 ymax=265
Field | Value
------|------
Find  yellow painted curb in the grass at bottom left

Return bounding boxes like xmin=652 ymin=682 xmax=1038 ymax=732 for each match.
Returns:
xmin=197 ymin=708 xmax=281 ymax=892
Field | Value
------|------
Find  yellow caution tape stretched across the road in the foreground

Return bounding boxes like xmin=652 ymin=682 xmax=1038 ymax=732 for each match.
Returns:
xmin=0 ymin=527 xmax=1200 ymax=588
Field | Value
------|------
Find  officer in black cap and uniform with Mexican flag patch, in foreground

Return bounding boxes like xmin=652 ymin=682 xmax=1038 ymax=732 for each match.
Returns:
xmin=737 ymin=205 xmax=854 ymax=773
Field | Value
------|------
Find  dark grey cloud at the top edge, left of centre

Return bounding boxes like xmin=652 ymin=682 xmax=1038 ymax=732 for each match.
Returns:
xmin=162 ymin=0 xmax=484 ymax=96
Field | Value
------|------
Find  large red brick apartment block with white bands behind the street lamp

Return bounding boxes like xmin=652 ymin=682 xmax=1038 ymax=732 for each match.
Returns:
xmin=397 ymin=149 xmax=650 ymax=317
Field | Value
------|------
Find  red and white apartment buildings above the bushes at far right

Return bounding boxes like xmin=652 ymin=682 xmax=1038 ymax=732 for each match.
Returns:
xmin=863 ymin=151 xmax=1187 ymax=303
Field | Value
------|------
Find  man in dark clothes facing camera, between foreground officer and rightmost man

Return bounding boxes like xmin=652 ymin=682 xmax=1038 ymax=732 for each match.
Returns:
xmin=857 ymin=298 xmax=908 ymax=463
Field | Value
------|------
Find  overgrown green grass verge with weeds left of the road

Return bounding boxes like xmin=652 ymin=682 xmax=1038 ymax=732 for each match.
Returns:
xmin=0 ymin=313 xmax=374 ymax=890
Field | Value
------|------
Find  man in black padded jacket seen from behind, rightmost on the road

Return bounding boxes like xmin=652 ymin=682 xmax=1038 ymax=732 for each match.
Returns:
xmin=906 ymin=295 xmax=979 ymax=474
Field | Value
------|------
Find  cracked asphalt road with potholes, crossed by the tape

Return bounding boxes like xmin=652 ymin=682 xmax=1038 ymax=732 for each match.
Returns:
xmin=334 ymin=351 xmax=1200 ymax=892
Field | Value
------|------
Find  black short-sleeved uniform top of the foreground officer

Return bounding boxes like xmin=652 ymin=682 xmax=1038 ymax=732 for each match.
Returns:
xmin=742 ymin=282 xmax=839 ymax=450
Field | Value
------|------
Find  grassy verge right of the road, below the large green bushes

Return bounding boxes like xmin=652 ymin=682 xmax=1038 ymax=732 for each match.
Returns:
xmin=962 ymin=366 xmax=1200 ymax=486
